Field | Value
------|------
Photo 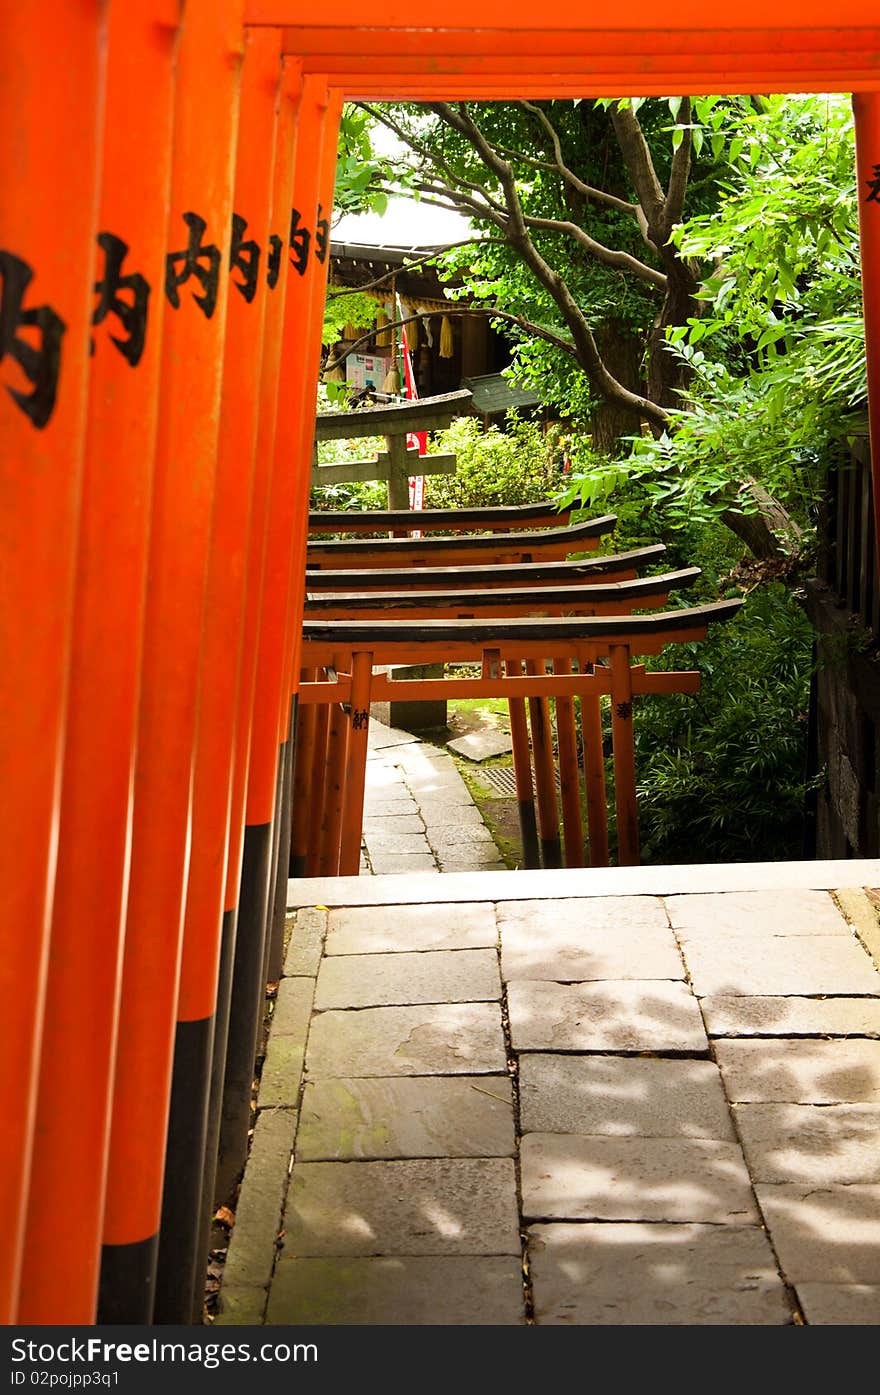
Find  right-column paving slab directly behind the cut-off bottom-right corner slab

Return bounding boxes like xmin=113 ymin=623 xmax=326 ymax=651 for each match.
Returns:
xmin=754 ymin=1183 xmax=880 ymax=1285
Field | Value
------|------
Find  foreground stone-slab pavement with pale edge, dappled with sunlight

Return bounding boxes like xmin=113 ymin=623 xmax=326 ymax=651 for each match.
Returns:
xmin=216 ymin=854 xmax=880 ymax=1325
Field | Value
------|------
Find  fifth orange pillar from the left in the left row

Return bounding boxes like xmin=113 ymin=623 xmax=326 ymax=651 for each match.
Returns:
xmin=192 ymin=57 xmax=303 ymax=1321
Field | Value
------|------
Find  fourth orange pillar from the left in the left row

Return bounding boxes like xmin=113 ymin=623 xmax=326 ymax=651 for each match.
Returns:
xmin=153 ymin=29 xmax=283 ymax=1324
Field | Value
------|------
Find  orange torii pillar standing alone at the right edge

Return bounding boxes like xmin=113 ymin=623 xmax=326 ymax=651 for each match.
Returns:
xmin=852 ymin=92 xmax=880 ymax=560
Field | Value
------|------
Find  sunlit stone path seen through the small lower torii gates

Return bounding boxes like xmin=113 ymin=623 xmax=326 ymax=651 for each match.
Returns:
xmin=361 ymin=720 xmax=505 ymax=875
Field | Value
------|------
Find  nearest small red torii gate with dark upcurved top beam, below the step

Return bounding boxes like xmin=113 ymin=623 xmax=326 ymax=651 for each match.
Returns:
xmin=297 ymin=600 xmax=742 ymax=876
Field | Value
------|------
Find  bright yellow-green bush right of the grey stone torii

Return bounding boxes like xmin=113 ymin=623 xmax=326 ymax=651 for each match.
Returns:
xmin=425 ymin=413 xmax=561 ymax=509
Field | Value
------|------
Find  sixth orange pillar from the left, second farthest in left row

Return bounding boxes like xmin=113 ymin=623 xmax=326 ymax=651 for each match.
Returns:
xmin=216 ymin=78 xmax=339 ymax=1198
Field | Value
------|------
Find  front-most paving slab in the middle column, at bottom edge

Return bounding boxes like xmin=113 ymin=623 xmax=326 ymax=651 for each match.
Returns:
xmin=529 ymin=1225 xmax=791 ymax=1327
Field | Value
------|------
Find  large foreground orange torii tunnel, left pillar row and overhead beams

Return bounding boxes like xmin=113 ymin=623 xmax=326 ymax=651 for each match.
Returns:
xmin=0 ymin=0 xmax=880 ymax=1322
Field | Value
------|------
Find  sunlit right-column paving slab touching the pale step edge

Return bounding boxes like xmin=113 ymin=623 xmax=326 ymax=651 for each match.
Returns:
xmin=665 ymin=891 xmax=852 ymax=940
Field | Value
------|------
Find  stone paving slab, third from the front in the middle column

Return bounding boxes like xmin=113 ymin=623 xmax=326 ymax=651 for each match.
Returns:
xmin=519 ymin=1055 xmax=735 ymax=1143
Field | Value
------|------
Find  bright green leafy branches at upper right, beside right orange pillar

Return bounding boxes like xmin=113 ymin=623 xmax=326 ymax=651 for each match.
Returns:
xmin=560 ymin=96 xmax=866 ymax=547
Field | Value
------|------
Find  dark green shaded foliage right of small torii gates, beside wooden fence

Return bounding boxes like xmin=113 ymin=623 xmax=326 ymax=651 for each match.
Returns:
xmin=633 ymin=582 xmax=812 ymax=862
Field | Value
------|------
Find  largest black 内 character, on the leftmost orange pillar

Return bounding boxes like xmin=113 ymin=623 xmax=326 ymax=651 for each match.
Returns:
xmin=0 ymin=251 xmax=67 ymax=430
